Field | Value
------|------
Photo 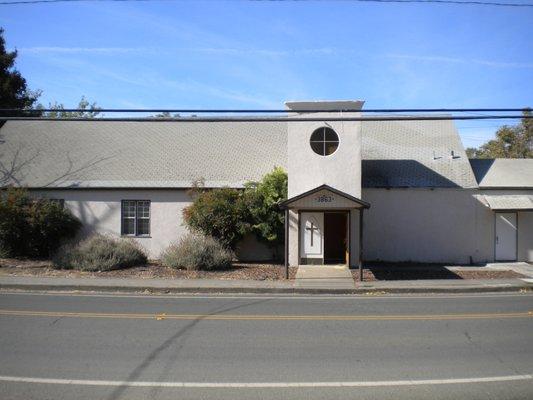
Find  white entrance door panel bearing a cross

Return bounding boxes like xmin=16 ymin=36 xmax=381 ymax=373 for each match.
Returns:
xmin=300 ymin=212 xmax=324 ymax=261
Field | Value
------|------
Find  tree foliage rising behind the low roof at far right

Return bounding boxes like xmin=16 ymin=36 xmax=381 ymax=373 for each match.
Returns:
xmin=466 ymin=110 xmax=533 ymax=158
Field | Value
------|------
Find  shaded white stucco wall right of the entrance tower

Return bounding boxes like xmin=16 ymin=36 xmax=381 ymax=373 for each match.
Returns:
xmin=363 ymin=189 xmax=533 ymax=264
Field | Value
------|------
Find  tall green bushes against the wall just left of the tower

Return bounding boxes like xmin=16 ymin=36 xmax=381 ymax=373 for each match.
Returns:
xmin=183 ymin=168 xmax=287 ymax=255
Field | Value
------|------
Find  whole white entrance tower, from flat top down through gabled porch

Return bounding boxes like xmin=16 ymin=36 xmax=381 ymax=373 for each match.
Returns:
xmin=282 ymin=100 xmax=370 ymax=273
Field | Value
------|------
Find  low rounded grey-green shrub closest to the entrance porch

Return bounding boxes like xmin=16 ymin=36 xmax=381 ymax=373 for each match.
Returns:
xmin=161 ymin=234 xmax=233 ymax=271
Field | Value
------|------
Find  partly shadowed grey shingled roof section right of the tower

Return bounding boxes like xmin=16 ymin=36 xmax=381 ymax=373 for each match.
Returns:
xmin=362 ymin=121 xmax=477 ymax=188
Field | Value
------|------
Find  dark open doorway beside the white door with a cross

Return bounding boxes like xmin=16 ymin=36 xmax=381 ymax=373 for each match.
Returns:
xmin=324 ymin=212 xmax=348 ymax=264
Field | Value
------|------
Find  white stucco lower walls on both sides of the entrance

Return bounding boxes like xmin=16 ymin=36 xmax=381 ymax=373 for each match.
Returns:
xmin=32 ymin=189 xmax=533 ymax=265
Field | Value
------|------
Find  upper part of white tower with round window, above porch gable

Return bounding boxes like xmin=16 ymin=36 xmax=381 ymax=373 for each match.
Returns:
xmin=285 ymin=100 xmax=364 ymax=198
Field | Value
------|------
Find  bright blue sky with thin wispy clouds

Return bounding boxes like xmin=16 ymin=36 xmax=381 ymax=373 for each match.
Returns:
xmin=0 ymin=0 xmax=533 ymax=146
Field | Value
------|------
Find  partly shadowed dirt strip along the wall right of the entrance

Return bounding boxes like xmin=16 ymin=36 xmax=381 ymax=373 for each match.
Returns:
xmin=352 ymin=264 xmax=525 ymax=282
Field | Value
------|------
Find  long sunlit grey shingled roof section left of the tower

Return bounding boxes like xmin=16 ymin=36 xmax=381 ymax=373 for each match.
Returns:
xmin=0 ymin=121 xmax=287 ymax=187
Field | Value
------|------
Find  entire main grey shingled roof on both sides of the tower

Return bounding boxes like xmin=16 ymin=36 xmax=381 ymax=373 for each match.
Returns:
xmin=0 ymin=121 xmax=476 ymax=188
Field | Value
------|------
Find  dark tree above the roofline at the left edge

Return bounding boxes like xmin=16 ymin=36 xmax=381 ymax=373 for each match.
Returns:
xmin=0 ymin=28 xmax=41 ymax=115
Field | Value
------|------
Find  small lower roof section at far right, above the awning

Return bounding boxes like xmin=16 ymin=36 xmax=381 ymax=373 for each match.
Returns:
xmin=470 ymin=158 xmax=533 ymax=188
